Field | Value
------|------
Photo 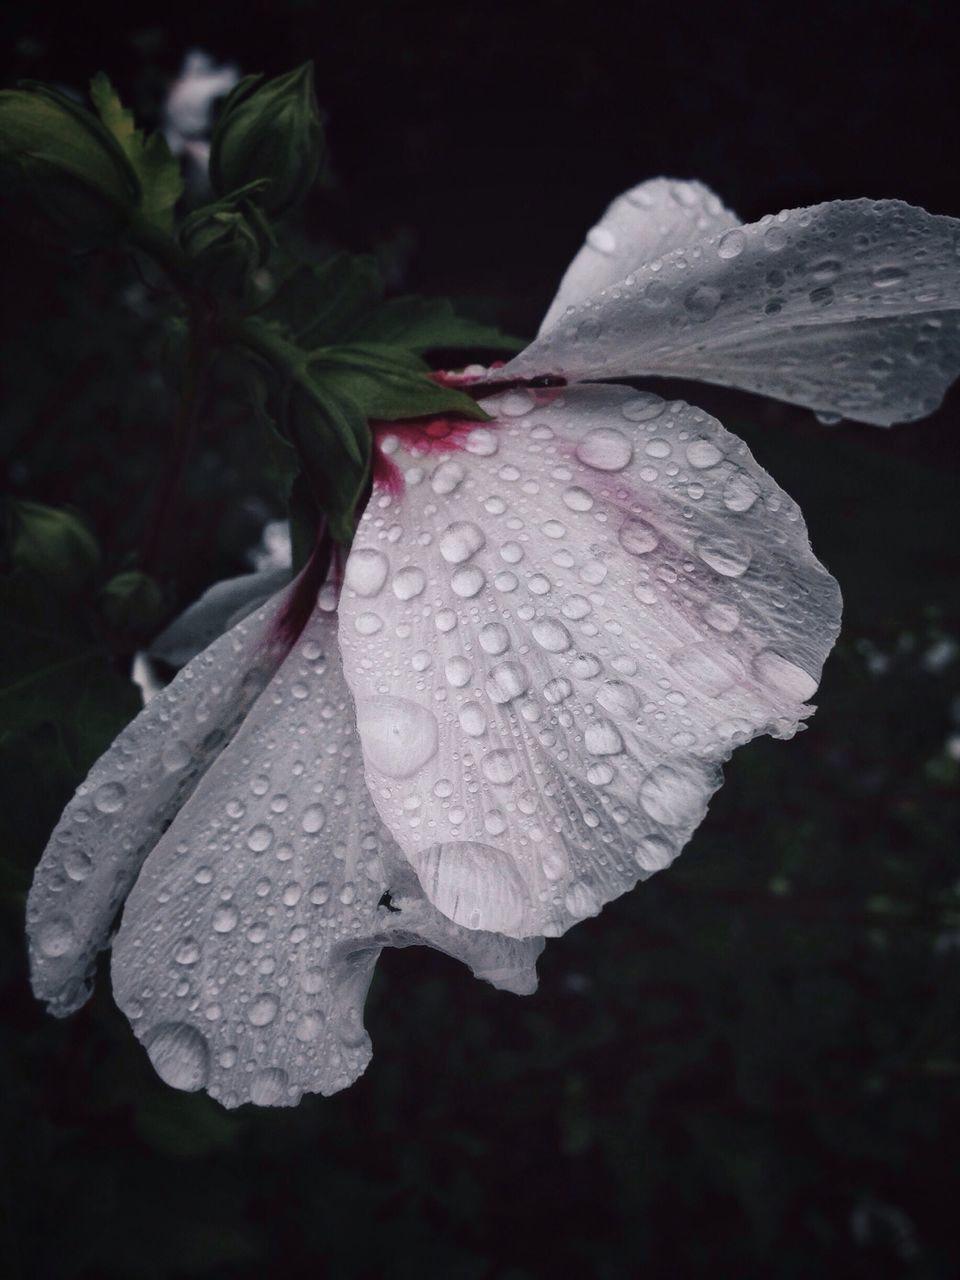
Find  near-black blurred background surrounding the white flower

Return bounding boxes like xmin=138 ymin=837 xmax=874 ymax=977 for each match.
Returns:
xmin=0 ymin=0 xmax=960 ymax=1280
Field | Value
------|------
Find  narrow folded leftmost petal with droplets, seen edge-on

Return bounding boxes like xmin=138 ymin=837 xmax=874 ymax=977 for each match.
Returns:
xmin=27 ymin=593 xmax=289 ymax=1016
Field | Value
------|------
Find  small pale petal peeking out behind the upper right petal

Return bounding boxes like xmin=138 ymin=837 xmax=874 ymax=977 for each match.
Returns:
xmin=540 ymin=178 xmax=740 ymax=333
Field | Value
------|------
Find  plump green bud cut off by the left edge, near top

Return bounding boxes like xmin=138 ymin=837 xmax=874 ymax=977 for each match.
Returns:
xmin=0 ymin=84 xmax=140 ymax=246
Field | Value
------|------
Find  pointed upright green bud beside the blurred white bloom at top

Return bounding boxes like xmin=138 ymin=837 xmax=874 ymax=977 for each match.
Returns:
xmin=210 ymin=63 xmax=324 ymax=214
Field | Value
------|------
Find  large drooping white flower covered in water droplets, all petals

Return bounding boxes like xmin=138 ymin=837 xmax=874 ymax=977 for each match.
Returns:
xmin=28 ymin=180 xmax=960 ymax=1106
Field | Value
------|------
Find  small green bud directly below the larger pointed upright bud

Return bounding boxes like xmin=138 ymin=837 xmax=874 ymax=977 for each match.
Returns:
xmin=180 ymin=201 xmax=270 ymax=298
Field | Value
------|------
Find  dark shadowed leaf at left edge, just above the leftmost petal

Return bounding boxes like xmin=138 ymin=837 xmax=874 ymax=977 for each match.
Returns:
xmin=0 ymin=573 xmax=141 ymax=774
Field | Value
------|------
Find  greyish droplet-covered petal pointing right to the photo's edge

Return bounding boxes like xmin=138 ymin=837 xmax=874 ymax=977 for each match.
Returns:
xmin=500 ymin=200 xmax=960 ymax=426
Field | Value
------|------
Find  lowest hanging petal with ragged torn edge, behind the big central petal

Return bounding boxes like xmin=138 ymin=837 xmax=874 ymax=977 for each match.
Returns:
xmin=113 ymin=611 xmax=543 ymax=1107
